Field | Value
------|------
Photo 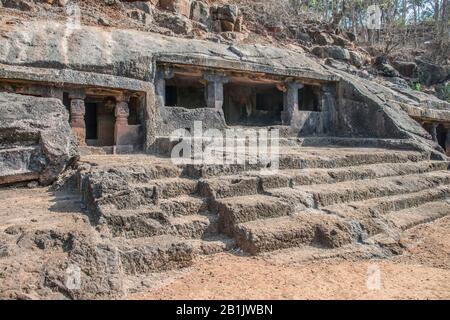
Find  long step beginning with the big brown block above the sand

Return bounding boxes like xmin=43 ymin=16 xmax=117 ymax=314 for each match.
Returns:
xmin=235 ymin=185 xmax=450 ymax=254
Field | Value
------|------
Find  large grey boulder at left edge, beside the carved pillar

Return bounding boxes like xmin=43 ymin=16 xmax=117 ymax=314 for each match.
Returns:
xmin=0 ymin=93 xmax=79 ymax=185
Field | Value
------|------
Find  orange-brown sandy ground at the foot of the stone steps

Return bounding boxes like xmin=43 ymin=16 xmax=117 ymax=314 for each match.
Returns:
xmin=128 ymin=217 xmax=450 ymax=299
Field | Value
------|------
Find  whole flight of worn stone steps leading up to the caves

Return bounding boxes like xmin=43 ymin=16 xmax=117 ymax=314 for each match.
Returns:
xmin=80 ymin=148 xmax=450 ymax=275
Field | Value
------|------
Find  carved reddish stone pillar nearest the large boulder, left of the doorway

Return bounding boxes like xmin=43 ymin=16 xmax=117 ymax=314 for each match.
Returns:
xmin=69 ymin=91 xmax=86 ymax=146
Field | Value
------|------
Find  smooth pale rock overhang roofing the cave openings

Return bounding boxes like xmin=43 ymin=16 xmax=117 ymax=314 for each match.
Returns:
xmin=0 ymin=21 xmax=338 ymax=81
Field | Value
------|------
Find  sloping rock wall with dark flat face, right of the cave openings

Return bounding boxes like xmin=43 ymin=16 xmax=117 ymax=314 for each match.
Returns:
xmin=330 ymin=70 xmax=444 ymax=159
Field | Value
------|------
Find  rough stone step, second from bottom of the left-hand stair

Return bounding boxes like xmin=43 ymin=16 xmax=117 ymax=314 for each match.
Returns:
xmin=105 ymin=208 xmax=219 ymax=239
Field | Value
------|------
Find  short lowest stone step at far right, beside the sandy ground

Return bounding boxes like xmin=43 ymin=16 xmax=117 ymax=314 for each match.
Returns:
xmin=386 ymin=199 xmax=450 ymax=230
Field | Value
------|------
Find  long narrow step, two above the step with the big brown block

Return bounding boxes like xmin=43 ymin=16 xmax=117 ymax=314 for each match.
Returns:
xmin=199 ymin=161 xmax=449 ymax=198
